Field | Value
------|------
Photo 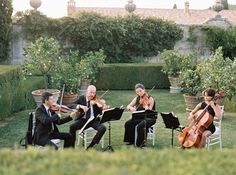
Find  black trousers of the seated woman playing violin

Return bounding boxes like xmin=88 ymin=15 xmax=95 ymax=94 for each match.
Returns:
xmin=124 ymin=118 xmax=156 ymax=146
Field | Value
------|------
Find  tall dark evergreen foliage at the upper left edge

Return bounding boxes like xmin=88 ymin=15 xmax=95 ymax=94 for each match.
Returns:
xmin=0 ymin=0 xmax=13 ymax=62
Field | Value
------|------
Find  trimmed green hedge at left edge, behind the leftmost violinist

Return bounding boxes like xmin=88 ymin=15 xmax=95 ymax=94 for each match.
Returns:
xmin=0 ymin=66 xmax=44 ymax=120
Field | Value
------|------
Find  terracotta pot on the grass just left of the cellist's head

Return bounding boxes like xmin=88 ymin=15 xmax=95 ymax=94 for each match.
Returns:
xmin=183 ymin=94 xmax=203 ymax=111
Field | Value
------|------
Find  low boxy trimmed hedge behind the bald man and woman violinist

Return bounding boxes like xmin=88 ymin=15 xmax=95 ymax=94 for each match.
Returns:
xmin=95 ymin=63 xmax=170 ymax=90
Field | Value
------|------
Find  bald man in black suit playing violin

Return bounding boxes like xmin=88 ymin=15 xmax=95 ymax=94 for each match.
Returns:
xmin=70 ymin=85 xmax=106 ymax=149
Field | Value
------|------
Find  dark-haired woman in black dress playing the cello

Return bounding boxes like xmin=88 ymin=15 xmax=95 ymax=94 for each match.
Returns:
xmin=188 ymin=89 xmax=222 ymax=148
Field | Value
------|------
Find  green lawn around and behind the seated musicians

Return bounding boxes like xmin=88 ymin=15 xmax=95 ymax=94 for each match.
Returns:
xmin=0 ymin=90 xmax=236 ymax=150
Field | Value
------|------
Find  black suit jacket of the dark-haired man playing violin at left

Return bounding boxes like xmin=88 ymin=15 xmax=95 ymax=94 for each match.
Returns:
xmin=34 ymin=104 xmax=72 ymax=146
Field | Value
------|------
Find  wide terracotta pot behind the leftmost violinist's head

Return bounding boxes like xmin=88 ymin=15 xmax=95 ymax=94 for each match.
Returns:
xmin=31 ymin=89 xmax=61 ymax=106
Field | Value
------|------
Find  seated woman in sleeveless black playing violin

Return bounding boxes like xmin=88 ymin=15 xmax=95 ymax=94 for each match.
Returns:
xmin=124 ymin=83 xmax=156 ymax=147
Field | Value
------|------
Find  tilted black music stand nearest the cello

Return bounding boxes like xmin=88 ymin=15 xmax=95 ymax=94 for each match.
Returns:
xmin=161 ymin=112 xmax=182 ymax=148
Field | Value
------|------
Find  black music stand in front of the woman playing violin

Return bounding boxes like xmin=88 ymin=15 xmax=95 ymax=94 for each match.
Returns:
xmin=132 ymin=109 xmax=157 ymax=146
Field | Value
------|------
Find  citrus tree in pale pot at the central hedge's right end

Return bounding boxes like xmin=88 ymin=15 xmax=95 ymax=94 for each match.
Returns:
xmin=160 ymin=50 xmax=193 ymax=93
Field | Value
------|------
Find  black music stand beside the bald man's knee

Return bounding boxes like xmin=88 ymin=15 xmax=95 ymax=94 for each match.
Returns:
xmin=100 ymin=108 xmax=124 ymax=152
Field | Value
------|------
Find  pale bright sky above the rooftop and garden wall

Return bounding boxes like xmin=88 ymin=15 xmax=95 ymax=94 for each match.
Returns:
xmin=12 ymin=0 xmax=236 ymax=18
